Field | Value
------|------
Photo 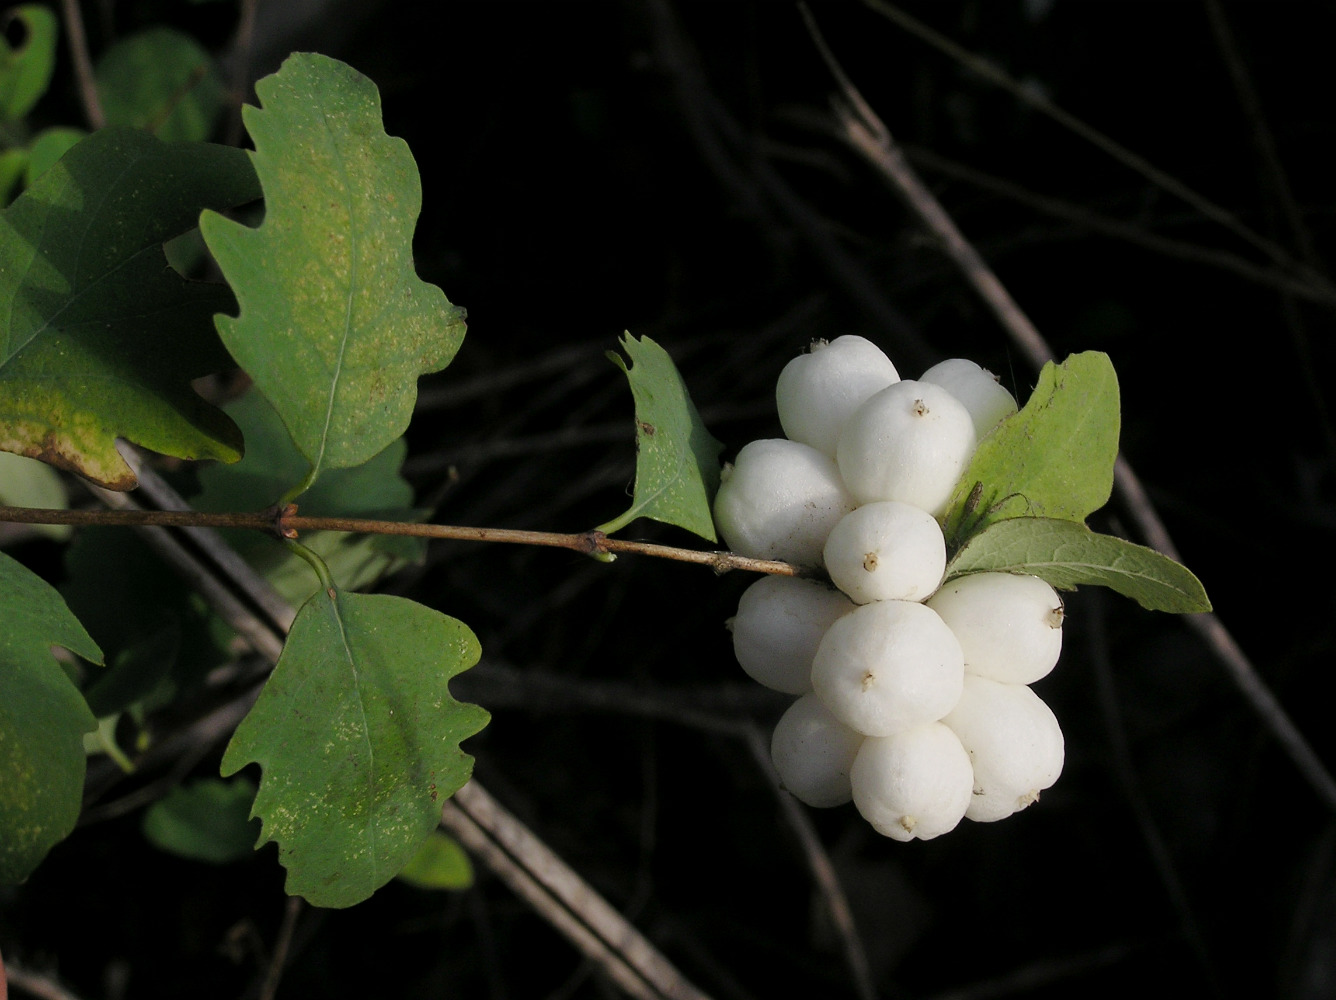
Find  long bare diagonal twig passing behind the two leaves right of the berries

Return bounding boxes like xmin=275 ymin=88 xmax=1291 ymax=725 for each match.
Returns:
xmin=802 ymin=7 xmax=1336 ymax=810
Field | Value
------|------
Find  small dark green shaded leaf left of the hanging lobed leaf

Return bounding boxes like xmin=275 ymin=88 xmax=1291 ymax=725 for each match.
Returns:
xmin=143 ymin=778 xmax=259 ymax=865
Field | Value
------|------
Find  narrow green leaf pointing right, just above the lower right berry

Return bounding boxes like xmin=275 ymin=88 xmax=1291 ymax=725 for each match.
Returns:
xmin=946 ymin=518 xmax=1210 ymax=614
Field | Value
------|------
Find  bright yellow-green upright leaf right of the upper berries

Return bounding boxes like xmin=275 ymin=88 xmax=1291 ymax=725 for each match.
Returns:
xmin=946 ymin=351 xmax=1120 ymax=546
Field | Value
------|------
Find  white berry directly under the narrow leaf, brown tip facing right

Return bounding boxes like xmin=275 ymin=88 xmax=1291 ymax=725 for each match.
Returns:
xmin=927 ymin=573 xmax=1062 ymax=684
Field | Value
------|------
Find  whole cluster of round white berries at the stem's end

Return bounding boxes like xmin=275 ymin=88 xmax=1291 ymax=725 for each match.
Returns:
xmin=715 ymin=336 xmax=1063 ymax=841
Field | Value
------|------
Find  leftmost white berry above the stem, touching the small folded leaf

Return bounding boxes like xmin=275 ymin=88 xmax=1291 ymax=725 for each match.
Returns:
xmin=715 ymin=438 xmax=856 ymax=566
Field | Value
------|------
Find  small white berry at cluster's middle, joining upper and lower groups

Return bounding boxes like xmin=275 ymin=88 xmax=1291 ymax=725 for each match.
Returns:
xmin=823 ymin=501 xmax=946 ymax=605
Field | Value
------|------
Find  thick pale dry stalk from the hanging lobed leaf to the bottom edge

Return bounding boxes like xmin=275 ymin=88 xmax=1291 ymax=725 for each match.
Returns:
xmin=441 ymin=781 xmax=708 ymax=1000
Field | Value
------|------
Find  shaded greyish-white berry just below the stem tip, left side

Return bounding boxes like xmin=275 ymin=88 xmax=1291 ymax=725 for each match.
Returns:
xmin=731 ymin=577 xmax=854 ymax=694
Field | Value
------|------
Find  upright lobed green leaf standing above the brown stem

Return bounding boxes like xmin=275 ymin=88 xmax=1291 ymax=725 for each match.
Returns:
xmin=200 ymin=53 xmax=464 ymax=495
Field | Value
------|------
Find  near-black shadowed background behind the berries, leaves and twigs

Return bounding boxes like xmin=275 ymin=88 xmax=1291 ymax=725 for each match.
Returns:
xmin=0 ymin=0 xmax=1336 ymax=1000
